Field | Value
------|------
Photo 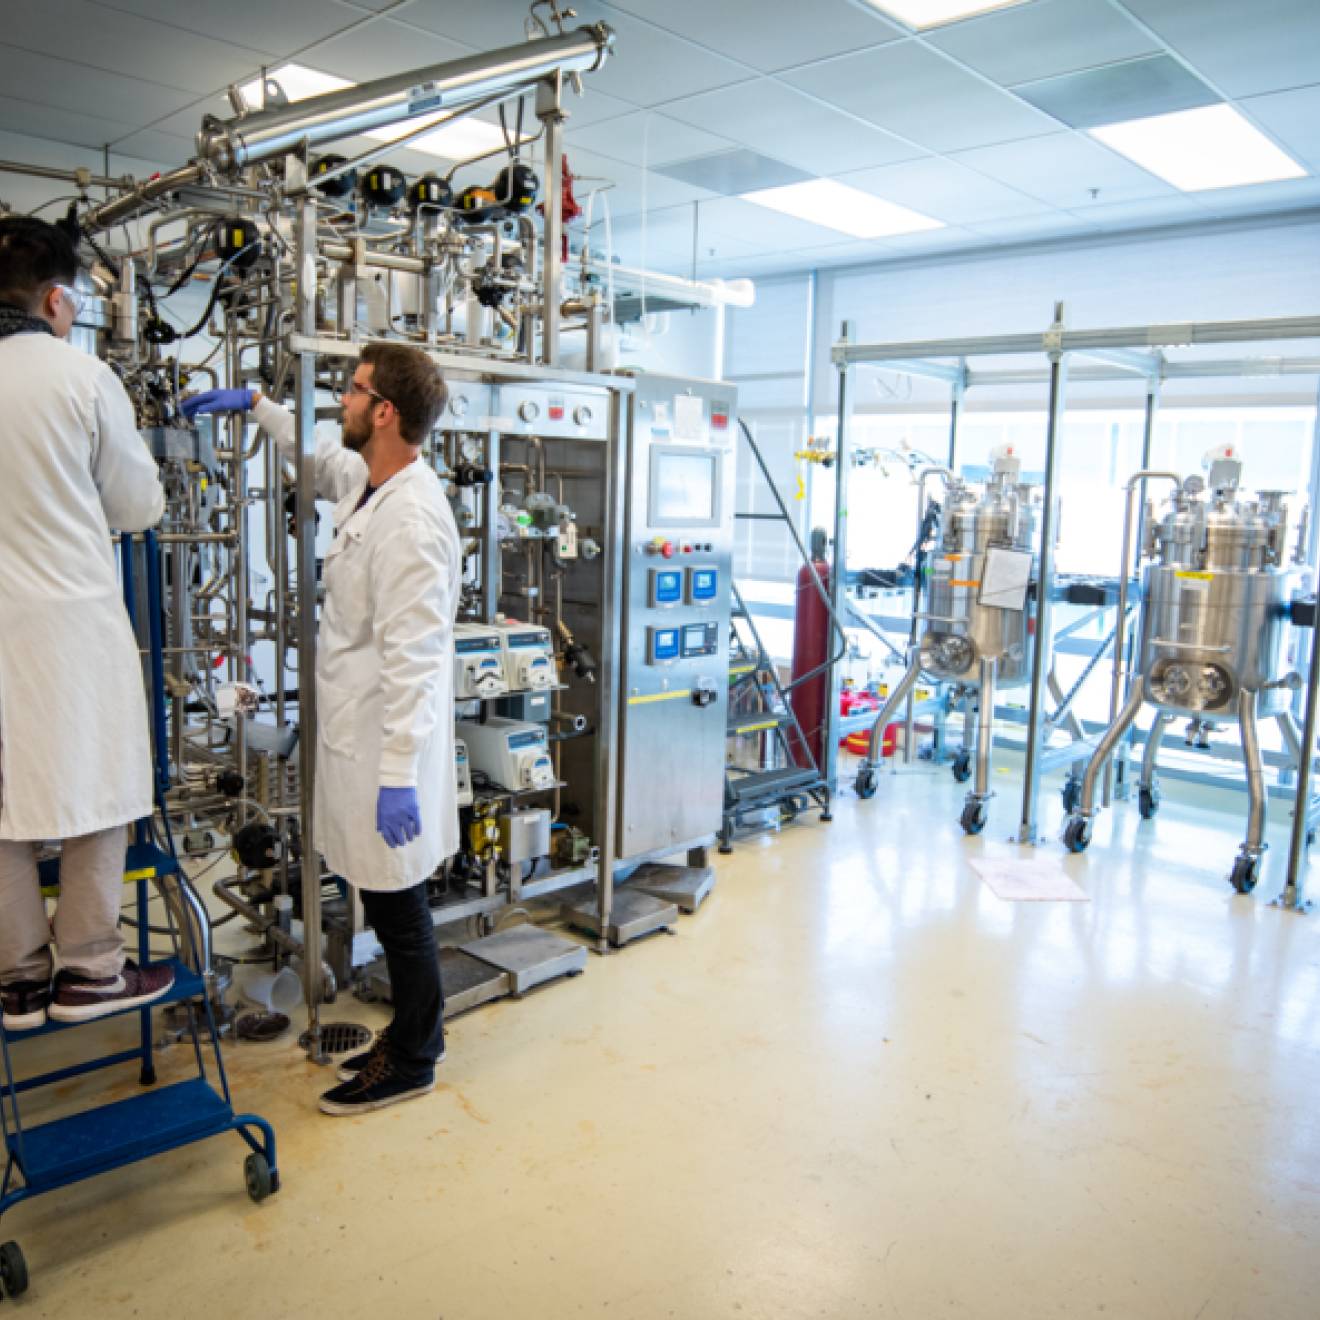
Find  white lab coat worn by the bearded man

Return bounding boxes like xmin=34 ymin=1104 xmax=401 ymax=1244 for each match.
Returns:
xmin=253 ymin=399 xmax=462 ymax=890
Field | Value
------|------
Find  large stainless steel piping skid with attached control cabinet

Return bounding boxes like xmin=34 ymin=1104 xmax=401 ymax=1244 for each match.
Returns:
xmin=0 ymin=0 xmax=734 ymax=1056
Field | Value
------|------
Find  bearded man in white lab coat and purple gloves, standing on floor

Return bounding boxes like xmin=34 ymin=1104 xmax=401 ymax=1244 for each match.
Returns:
xmin=183 ymin=343 xmax=462 ymax=1115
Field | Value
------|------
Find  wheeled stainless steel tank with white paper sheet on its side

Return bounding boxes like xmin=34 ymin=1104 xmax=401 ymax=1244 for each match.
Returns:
xmin=855 ymin=451 xmax=1040 ymax=834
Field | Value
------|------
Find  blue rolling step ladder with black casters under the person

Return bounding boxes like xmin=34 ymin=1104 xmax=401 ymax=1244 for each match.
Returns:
xmin=0 ymin=533 xmax=280 ymax=1296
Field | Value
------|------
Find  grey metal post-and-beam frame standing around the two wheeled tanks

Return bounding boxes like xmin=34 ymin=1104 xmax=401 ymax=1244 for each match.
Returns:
xmin=832 ymin=315 xmax=1320 ymax=881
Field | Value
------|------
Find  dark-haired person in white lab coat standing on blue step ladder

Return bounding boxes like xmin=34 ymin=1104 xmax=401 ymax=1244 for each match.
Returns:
xmin=0 ymin=216 xmax=174 ymax=1031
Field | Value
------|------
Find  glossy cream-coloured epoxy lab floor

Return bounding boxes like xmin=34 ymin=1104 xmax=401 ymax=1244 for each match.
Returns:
xmin=0 ymin=767 xmax=1320 ymax=1320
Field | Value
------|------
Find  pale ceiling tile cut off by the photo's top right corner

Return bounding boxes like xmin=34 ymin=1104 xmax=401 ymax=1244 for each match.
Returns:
xmin=1122 ymin=0 xmax=1320 ymax=96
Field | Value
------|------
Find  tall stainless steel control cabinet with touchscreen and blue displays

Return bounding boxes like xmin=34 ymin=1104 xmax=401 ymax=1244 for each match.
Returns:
xmin=618 ymin=375 xmax=737 ymax=861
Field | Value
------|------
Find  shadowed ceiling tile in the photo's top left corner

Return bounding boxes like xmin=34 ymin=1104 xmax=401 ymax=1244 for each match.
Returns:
xmin=4 ymin=0 xmax=261 ymax=94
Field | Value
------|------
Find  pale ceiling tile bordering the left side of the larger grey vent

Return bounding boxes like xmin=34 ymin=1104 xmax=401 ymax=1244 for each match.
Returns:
xmin=784 ymin=41 xmax=1055 ymax=152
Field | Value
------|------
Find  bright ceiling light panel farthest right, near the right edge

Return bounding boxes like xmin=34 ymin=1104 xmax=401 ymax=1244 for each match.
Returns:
xmin=1090 ymin=106 xmax=1307 ymax=193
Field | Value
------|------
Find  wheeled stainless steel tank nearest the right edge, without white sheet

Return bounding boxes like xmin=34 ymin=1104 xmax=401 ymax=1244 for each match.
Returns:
xmin=1063 ymin=453 xmax=1309 ymax=894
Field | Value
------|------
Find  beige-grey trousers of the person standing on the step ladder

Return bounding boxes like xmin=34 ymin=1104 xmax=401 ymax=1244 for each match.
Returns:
xmin=0 ymin=825 xmax=128 ymax=985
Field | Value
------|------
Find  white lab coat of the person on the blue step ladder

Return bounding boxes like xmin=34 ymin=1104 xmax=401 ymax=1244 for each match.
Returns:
xmin=0 ymin=334 xmax=165 ymax=840
